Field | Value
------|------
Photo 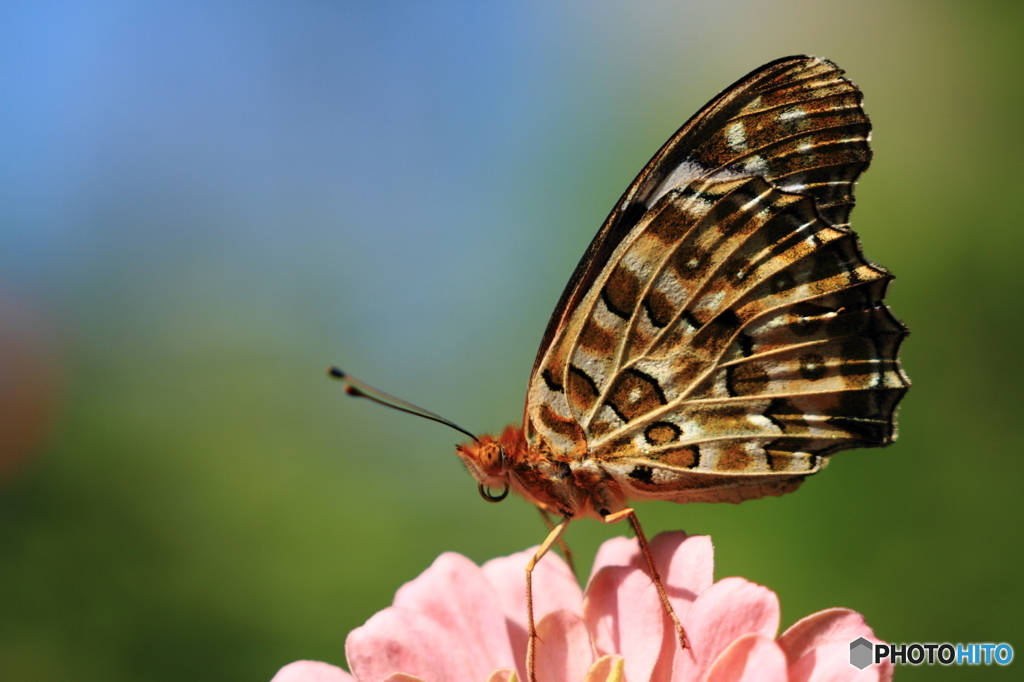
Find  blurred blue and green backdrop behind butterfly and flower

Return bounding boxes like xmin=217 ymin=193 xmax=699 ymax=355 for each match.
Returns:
xmin=0 ymin=0 xmax=1024 ymax=682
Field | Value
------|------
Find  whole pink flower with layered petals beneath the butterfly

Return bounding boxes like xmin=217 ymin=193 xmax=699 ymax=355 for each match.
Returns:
xmin=272 ymin=531 xmax=893 ymax=682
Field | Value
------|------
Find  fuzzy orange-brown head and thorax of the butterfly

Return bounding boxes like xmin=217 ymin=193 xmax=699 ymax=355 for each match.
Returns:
xmin=456 ymin=425 xmax=626 ymax=518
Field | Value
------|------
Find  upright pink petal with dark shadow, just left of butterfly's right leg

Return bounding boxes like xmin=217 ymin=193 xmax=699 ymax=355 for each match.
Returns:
xmin=583 ymin=566 xmax=663 ymax=680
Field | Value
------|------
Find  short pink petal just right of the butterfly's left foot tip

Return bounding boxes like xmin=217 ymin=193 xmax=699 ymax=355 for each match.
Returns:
xmin=536 ymin=610 xmax=594 ymax=682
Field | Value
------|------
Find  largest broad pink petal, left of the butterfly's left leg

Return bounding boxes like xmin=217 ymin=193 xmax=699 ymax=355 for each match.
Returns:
xmin=345 ymin=553 xmax=514 ymax=682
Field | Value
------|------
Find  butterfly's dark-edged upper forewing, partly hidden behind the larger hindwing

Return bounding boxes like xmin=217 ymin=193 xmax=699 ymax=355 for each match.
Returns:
xmin=534 ymin=56 xmax=871 ymax=382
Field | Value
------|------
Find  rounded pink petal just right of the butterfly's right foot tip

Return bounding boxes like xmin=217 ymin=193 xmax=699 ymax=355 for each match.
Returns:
xmin=673 ymin=578 xmax=779 ymax=680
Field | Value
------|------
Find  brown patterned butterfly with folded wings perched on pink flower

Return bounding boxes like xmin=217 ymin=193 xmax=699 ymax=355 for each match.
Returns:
xmin=332 ymin=56 xmax=910 ymax=680
